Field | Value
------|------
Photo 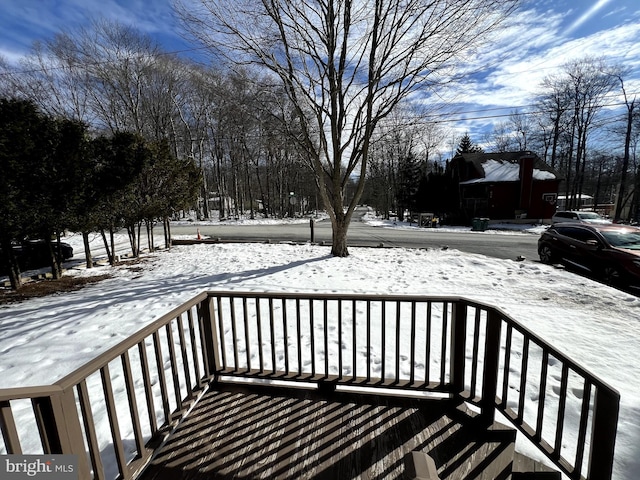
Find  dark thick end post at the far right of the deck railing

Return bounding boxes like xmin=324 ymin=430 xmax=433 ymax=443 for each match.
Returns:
xmin=588 ymin=386 xmax=620 ymax=480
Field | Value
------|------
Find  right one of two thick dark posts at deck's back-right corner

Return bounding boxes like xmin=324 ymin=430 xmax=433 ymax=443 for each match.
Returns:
xmin=480 ymin=310 xmax=502 ymax=424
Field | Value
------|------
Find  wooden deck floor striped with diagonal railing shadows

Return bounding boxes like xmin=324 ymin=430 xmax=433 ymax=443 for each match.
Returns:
xmin=140 ymin=384 xmax=514 ymax=480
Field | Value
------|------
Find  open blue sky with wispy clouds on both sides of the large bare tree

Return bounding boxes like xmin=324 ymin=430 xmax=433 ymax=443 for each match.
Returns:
xmin=0 ymin=0 xmax=640 ymax=145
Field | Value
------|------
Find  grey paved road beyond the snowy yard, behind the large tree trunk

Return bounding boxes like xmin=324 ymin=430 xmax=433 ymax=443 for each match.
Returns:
xmin=166 ymin=210 xmax=538 ymax=261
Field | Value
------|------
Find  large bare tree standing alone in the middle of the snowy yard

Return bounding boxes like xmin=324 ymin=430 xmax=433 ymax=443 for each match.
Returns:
xmin=176 ymin=0 xmax=517 ymax=256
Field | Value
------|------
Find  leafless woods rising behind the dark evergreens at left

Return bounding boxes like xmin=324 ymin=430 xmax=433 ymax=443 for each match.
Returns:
xmin=0 ymin=20 xmax=318 ymax=225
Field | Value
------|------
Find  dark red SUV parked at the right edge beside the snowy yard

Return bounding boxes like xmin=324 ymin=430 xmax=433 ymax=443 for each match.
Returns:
xmin=538 ymin=223 xmax=640 ymax=286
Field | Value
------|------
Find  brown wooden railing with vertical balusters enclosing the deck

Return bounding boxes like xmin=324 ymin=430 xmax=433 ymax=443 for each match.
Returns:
xmin=0 ymin=292 xmax=619 ymax=480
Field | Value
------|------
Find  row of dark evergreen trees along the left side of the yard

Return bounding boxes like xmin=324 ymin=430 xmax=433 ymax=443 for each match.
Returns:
xmin=0 ymin=98 xmax=200 ymax=289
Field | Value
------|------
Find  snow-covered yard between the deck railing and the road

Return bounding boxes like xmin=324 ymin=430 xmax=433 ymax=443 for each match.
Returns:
xmin=0 ymin=218 xmax=640 ymax=480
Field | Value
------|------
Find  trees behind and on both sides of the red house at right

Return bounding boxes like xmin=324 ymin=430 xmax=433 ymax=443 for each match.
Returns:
xmin=364 ymin=57 xmax=640 ymax=223
